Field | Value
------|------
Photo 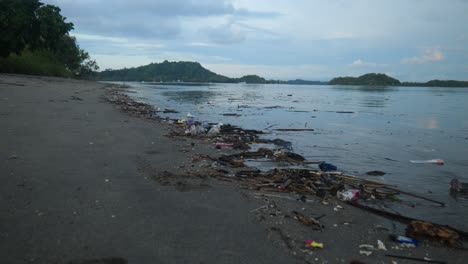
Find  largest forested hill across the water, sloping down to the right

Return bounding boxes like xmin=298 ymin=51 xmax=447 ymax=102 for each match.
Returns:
xmin=97 ymin=61 xmax=267 ymax=83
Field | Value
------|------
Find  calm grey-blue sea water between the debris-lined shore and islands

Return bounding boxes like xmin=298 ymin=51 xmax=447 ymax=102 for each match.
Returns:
xmin=124 ymin=83 xmax=468 ymax=230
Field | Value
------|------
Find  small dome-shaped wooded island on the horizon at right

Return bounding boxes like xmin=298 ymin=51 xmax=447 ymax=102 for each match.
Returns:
xmin=330 ymin=73 xmax=401 ymax=86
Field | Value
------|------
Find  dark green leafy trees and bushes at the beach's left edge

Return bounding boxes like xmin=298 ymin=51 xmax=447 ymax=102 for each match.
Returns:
xmin=0 ymin=0 xmax=99 ymax=78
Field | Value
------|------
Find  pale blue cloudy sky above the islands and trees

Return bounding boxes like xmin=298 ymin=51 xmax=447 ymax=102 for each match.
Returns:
xmin=43 ymin=0 xmax=468 ymax=81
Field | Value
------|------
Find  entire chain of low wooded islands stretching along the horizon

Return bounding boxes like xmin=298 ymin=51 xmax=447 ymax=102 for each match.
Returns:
xmin=95 ymin=60 xmax=468 ymax=87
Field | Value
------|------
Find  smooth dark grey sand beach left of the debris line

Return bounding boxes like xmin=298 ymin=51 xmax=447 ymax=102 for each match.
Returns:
xmin=0 ymin=75 xmax=468 ymax=264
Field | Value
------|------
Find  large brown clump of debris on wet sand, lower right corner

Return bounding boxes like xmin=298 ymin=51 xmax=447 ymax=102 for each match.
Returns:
xmin=406 ymin=221 xmax=462 ymax=247
